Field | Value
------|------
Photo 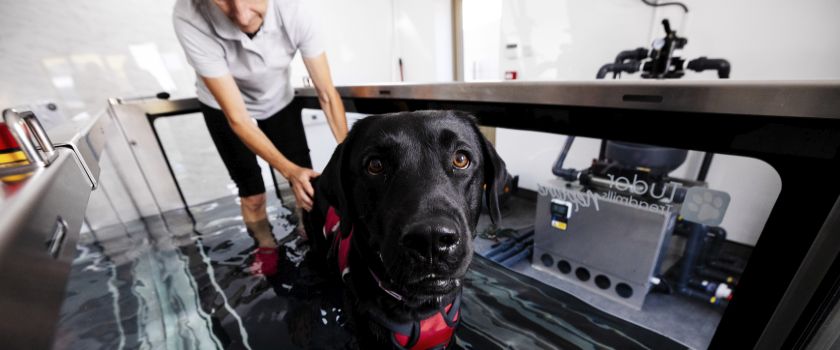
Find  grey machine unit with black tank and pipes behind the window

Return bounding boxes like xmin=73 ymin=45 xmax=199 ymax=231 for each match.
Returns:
xmin=532 ymin=136 xmax=743 ymax=309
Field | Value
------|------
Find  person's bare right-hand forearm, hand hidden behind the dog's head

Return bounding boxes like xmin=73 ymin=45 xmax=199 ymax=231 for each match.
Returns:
xmin=303 ymin=53 xmax=347 ymax=143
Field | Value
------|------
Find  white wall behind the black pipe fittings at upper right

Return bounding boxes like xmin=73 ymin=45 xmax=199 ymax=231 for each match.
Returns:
xmin=476 ymin=0 xmax=840 ymax=80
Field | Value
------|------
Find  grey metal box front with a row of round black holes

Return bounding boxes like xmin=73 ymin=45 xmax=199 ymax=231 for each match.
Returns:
xmin=532 ymin=179 xmax=675 ymax=309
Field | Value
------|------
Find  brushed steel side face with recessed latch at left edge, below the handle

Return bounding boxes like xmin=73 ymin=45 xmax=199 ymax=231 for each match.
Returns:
xmin=0 ymin=148 xmax=90 ymax=349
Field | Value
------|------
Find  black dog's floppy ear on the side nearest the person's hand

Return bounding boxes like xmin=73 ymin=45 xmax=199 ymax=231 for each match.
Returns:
xmin=318 ymin=135 xmax=355 ymax=235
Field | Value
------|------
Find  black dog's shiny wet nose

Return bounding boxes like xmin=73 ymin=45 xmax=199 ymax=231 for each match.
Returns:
xmin=401 ymin=223 xmax=460 ymax=258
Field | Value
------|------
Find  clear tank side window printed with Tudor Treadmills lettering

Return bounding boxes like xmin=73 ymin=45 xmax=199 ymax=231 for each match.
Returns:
xmin=502 ymin=132 xmax=781 ymax=348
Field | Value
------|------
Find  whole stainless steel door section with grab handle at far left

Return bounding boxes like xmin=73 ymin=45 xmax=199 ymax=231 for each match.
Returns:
xmin=0 ymin=104 xmax=108 ymax=349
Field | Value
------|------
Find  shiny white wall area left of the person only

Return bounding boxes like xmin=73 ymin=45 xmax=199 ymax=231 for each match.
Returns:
xmin=0 ymin=0 xmax=195 ymax=115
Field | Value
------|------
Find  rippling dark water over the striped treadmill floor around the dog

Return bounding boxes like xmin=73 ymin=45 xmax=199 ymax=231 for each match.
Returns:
xmin=54 ymin=198 xmax=683 ymax=349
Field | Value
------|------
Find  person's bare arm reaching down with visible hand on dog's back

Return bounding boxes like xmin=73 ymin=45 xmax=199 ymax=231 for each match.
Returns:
xmin=201 ymin=74 xmax=318 ymax=211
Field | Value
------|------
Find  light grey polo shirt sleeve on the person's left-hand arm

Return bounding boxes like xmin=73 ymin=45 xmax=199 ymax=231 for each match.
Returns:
xmin=173 ymin=15 xmax=230 ymax=78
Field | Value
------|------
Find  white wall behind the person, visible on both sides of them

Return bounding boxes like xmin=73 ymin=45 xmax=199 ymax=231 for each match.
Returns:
xmin=0 ymin=0 xmax=452 ymax=115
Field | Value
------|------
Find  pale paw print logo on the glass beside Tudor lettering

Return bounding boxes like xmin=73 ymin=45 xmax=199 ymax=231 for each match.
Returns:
xmin=680 ymin=187 xmax=730 ymax=226
